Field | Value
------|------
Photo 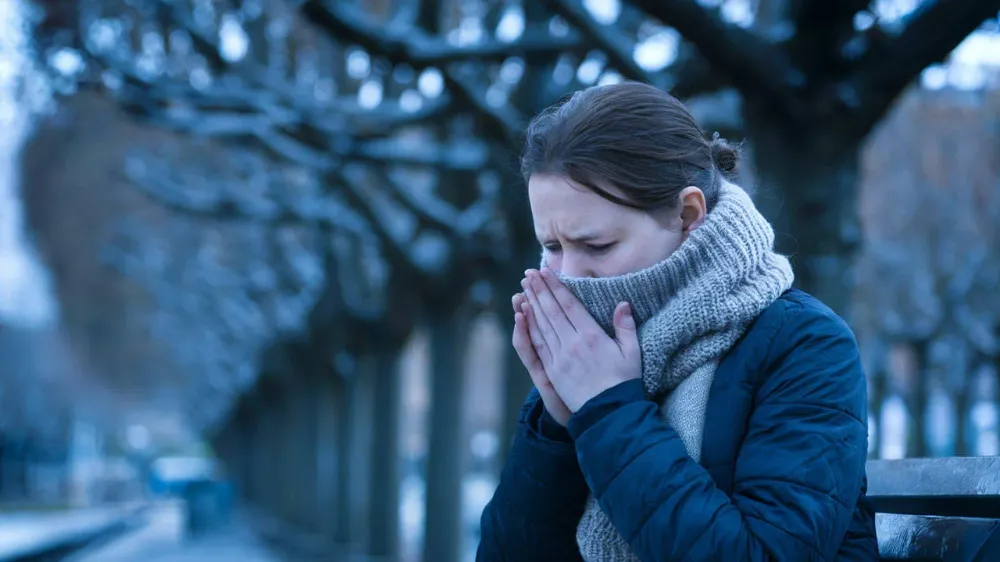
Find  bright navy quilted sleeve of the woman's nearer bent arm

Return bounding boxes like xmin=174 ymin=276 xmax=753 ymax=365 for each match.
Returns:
xmin=569 ymin=308 xmax=868 ymax=562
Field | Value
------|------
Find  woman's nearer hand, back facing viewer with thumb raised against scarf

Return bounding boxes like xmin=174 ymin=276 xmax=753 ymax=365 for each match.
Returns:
xmin=521 ymin=269 xmax=642 ymax=412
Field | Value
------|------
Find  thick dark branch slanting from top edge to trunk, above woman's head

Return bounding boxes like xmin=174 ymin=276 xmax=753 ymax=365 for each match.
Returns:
xmin=634 ymin=0 xmax=806 ymax=103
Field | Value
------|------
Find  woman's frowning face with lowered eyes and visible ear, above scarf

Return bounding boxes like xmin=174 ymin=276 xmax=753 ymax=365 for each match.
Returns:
xmin=528 ymin=174 xmax=707 ymax=277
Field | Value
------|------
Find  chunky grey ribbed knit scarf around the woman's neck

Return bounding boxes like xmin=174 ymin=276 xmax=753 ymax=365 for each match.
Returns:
xmin=548 ymin=182 xmax=794 ymax=562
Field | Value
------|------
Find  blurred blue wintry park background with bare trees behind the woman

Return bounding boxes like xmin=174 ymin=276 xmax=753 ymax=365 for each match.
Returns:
xmin=0 ymin=0 xmax=1000 ymax=562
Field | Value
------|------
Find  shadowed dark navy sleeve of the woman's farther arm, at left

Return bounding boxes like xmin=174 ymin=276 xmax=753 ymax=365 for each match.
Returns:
xmin=476 ymin=390 xmax=589 ymax=562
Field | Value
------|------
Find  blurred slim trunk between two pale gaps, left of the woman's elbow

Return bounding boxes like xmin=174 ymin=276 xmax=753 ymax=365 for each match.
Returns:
xmin=423 ymin=311 xmax=469 ymax=562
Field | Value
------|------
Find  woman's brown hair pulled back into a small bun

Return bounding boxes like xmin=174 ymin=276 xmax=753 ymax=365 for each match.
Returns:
xmin=521 ymin=82 xmax=739 ymax=211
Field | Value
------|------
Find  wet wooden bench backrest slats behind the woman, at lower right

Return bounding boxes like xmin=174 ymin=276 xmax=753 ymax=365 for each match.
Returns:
xmin=868 ymin=457 xmax=1000 ymax=562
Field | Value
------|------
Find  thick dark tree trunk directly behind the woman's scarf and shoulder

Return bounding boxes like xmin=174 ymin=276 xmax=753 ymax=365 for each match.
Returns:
xmin=745 ymin=118 xmax=861 ymax=318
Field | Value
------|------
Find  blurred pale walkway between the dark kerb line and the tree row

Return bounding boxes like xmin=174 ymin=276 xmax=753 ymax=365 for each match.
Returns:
xmin=71 ymin=503 xmax=279 ymax=562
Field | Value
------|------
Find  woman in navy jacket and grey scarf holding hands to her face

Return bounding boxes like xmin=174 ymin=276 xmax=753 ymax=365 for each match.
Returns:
xmin=477 ymin=83 xmax=877 ymax=562
